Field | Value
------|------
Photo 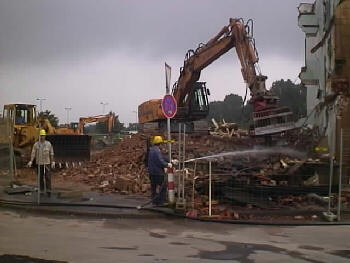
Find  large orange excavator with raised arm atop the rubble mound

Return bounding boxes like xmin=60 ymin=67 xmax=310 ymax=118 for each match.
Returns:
xmin=138 ymin=18 xmax=295 ymax=136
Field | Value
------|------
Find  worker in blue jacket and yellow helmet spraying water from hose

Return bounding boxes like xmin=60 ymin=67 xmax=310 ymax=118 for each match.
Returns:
xmin=148 ymin=136 xmax=172 ymax=205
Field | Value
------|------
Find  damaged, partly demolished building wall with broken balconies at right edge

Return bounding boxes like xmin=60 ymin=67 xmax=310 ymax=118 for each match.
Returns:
xmin=298 ymin=0 xmax=350 ymax=161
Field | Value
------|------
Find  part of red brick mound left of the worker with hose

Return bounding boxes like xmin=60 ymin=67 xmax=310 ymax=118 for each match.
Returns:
xmin=57 ymin=135 xmax=149 ymax=194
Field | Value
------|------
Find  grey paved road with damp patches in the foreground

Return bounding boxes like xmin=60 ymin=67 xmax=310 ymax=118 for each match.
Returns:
xmin=0 ymin=209 xmax=350 ymax=263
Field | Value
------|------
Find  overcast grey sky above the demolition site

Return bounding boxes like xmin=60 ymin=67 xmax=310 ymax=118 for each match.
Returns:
xmin=0 ymin=0 xmax=312 ymax=126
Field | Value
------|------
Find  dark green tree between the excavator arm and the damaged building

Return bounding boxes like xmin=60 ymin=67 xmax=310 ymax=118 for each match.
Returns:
xmin=271 ymin=79 xmax=306 ymax=118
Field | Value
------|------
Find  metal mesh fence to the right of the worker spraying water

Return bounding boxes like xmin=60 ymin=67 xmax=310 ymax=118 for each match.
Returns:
xmin=174 ymin=127 xmax=350 ymax=221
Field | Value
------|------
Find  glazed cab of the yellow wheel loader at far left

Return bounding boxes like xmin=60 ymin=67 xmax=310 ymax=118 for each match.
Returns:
xmin=3 ymin=104 xmax=36 ymax=126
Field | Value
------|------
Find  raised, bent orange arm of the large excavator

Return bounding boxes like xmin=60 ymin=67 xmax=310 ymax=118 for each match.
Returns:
xmin=173 ymin=18 xmax=267 ymax=110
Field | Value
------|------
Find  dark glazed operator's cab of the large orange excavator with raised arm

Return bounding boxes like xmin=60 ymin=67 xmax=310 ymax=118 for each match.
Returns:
xmin=189 ymin=82 xmax=210 ymax=119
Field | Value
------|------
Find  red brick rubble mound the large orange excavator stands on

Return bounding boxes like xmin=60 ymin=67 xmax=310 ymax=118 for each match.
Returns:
xmin=56 ymin=134 xmax=250 ymax=194
